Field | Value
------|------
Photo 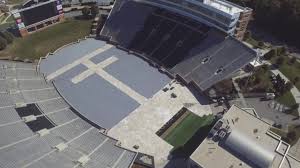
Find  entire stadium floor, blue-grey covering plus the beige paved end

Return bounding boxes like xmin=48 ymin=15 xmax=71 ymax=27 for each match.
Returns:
xmin=38 ymin=38 xmax=212 ymax=168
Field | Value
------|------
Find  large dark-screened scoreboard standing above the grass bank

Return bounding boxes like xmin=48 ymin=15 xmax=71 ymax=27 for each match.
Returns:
xmin=11 ymin=0 xmax=64 ymax=36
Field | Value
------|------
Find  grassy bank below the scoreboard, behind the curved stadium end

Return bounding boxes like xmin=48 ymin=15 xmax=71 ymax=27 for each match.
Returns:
xmin=0 ymin=19 xmax=92 ymax=60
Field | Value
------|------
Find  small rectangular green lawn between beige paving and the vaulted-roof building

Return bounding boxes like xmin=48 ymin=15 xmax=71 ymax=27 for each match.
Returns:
xmin=164 ymin=113 xmax=214 ymax=148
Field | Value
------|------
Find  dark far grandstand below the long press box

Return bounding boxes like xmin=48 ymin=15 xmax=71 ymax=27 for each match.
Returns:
xmin=100 ymin=0 xmax=256 ymax=91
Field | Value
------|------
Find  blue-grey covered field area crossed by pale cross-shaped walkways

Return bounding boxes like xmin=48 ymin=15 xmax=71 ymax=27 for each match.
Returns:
xmin=40 ymin=39 xmax=171 ymax=129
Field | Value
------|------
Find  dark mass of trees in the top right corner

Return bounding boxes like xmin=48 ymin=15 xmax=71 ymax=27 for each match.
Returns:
xmin=229 ymin=0 xmax=300 ymax=47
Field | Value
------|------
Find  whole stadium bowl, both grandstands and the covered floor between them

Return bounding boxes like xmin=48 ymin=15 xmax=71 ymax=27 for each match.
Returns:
xmin=0 ymin=0 xmax=256 ymax=168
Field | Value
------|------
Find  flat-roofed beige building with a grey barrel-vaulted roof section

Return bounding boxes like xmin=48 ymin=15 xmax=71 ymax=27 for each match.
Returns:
xmin=190 ymin=106 xmax=300 ymax=168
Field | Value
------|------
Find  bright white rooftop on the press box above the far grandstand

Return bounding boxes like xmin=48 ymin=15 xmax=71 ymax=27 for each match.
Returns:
xmin=203 ymin=0 xmax=244 ymax=15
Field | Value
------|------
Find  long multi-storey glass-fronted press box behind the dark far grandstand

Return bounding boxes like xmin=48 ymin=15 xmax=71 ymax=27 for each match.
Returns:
xmin=136 ymin=0 xmax=252 ymax=40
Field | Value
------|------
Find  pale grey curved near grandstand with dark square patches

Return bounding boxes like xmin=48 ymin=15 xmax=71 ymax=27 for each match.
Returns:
xmin=0 ymin=61 xmax=136 ymax=168
